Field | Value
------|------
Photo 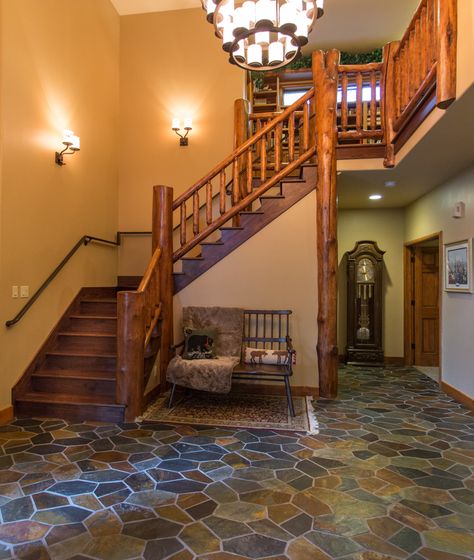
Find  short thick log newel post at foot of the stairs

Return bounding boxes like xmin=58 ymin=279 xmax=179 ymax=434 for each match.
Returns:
xmin=116 ymin=292 xmax=145 ymax=421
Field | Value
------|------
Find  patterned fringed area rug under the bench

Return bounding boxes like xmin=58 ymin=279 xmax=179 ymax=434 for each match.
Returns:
xmin=142 ymin=392 xmax=318 ymax=434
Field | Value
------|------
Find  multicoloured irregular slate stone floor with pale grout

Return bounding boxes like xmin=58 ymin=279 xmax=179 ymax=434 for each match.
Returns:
xmin=0 ymin=368 xmax=474 ymax=560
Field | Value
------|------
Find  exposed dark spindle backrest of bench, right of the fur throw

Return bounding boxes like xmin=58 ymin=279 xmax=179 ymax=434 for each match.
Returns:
xmin=242 ymin=309 xmax=292 ymax=350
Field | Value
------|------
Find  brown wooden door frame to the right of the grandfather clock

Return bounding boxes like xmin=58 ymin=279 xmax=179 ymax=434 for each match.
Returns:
xmin=403 ymin=231 xmax=444 ymax=383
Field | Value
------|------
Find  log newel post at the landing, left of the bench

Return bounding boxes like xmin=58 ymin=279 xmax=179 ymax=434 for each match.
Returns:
xmin=152 ymin=185 xmax=173 ymax=392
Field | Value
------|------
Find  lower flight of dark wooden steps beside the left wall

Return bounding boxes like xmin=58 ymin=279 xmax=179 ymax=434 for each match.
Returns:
xmin=13 ymin=288 xmax=125 ymax=422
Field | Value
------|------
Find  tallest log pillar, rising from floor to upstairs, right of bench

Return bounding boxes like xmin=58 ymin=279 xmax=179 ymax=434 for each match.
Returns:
xmin=313 ymin=50 xmax=339 ymax=398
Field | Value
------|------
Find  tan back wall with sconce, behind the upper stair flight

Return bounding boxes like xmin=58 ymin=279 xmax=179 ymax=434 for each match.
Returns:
xmin=119 ymin=9 xmax=244 ymax=275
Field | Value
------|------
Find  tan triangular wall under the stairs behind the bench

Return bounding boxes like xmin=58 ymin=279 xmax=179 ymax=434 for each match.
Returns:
xmin=174 ymin=192 xmax=318 ymax=387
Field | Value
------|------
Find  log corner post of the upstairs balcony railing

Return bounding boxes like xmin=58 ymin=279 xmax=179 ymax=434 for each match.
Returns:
xmin=380 ymin=41 xmax=400 ymax=167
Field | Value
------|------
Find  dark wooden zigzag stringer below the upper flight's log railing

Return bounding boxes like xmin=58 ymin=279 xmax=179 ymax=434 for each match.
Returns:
xmin=174 ymin=164 xmax=317 ymax=294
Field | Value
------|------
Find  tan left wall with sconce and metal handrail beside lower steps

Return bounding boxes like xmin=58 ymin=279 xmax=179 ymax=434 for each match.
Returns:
xmin=0 ymin=0 xmax=119 ymax=408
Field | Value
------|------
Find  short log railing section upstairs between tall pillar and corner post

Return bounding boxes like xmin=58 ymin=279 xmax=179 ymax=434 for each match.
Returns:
xmin=337 ymin=63 xmax=384 ymax=144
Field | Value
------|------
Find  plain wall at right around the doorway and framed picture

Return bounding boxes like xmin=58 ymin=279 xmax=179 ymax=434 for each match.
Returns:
xmin=405 ymin=163 xmax=474 ymax=397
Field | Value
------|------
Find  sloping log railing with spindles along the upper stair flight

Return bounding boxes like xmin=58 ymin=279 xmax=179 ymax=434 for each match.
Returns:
xmin=173 ymin=90 xmax=314 ymax=261
